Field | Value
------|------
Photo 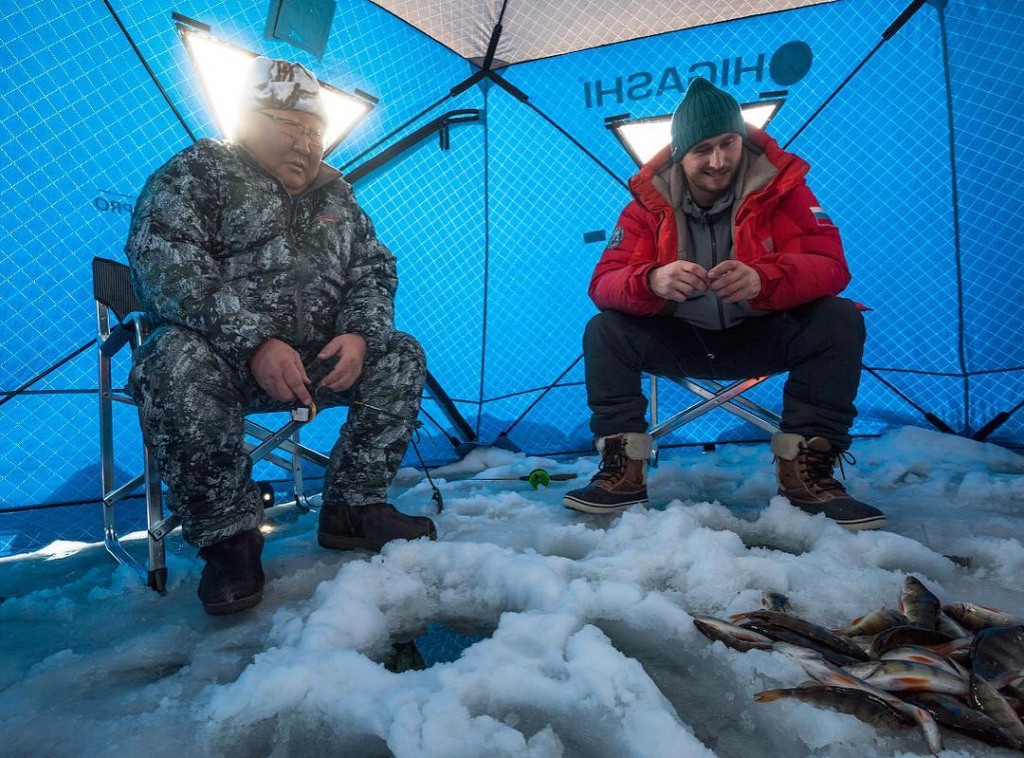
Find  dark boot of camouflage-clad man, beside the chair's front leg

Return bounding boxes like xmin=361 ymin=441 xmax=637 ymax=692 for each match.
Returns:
xmin=198 ymin=529 xmax=265 ymax=616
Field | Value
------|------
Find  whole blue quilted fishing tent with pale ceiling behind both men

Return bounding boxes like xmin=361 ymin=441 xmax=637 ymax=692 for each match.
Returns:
xmin=0 ymin=0 xmax=1024 ymax=551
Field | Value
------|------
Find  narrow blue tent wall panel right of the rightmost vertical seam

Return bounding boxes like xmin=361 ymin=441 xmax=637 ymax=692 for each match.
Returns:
xmin=943 ymin=2 xmax=1024 ymax=444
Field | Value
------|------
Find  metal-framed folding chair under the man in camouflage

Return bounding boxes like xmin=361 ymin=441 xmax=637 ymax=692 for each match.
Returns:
xmin=92 ymin=257 xmax=328 ymax=592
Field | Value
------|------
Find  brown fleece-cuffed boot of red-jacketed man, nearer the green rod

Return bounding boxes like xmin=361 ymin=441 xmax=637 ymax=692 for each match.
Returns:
xmin=562 ymin=432 xmax=651 ymax=513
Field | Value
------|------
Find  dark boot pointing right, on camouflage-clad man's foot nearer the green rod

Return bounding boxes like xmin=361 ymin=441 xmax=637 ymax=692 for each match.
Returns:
xmin=316 ymin=503 xmax=437 ymax=553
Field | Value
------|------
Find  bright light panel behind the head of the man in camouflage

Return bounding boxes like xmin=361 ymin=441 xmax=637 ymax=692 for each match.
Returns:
xmin=178 ymin=24 xmax=376 ymax=156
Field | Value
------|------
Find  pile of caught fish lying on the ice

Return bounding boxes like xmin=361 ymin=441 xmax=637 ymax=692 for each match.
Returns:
xmin=693 ymin=577 xmax=1024 ymax=753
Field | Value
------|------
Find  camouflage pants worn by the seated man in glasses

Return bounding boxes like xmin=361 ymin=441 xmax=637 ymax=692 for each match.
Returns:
xmin=131 ymin=326 xmax=426 ymax=547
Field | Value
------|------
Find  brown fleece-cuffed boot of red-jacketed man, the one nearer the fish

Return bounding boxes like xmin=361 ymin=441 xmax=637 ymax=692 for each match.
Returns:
xmin=771 ymin=432 xmax=886 ymax=532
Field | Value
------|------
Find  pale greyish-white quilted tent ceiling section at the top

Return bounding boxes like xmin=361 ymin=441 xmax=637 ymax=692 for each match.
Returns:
xmin=376 ymin=0 xmax=834 ymax=68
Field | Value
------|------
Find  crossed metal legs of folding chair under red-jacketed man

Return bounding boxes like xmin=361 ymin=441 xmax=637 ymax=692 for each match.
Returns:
xmin=648 ymin=374 xmax=782 ymax=465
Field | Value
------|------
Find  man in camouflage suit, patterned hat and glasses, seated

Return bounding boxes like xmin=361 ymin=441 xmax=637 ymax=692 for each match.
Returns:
xmin=126 ymin=58 xmax=436 ymax=615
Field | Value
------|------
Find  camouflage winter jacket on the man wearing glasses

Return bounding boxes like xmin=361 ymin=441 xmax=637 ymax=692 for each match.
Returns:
xmin=125 ymin=139 xmax=398 ymax=368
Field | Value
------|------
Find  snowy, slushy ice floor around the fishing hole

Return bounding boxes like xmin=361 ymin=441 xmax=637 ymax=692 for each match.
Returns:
xmin=0 ymin=428 xmax=1024 ymax=758
